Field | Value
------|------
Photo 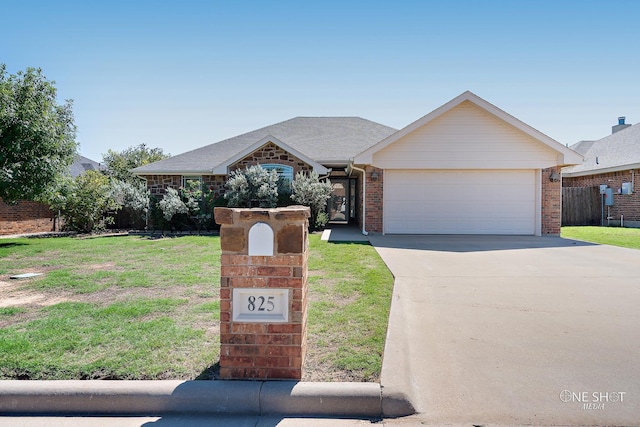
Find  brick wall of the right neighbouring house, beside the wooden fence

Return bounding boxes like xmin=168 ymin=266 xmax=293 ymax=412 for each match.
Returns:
xmin=562 ymin=169 xmax=640 ymax=226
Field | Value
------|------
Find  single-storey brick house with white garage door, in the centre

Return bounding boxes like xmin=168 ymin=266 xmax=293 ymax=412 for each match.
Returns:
xmin=133 ymin=92 xmax=582 ymax=235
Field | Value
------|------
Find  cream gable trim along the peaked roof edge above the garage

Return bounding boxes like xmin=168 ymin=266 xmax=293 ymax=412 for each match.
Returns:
xmin=353 ymin=91 xmax=582 ymax=165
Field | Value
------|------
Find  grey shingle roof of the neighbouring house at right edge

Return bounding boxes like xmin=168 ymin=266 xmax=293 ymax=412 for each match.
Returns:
xmin=562 ymin=124 xmax=640 ymax=176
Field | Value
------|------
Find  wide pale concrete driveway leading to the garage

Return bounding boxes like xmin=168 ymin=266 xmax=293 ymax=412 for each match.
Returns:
xmin=370 ymin=236 xmax=640 ymax=425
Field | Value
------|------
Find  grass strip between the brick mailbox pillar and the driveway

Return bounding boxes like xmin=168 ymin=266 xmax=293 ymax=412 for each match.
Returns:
xmin=308 ymin=241 xmax=393 ymax=381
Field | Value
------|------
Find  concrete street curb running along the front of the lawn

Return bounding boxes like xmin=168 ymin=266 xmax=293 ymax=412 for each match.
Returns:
xmin=0 ymin=380 xmax=396 ymax=418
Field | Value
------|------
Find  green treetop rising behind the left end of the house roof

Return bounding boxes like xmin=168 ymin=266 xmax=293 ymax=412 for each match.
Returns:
xmin=102 ymin=144 xmax=171 ymax=183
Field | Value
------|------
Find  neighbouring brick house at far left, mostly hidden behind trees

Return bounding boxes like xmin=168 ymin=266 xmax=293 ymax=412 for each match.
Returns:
xmin=0 ymin=154 xmax=101 ymax=235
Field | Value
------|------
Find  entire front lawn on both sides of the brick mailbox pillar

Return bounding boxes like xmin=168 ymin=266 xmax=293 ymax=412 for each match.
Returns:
xmin=0 ymin=235 xmax=393 ymax=381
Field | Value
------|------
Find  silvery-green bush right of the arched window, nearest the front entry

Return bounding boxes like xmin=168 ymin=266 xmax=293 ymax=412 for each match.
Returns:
xmin=291 ymin=172 xmax=331 ymax=228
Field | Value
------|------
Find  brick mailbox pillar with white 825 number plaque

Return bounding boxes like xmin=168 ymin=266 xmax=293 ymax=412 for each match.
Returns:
xmin=214 ymin=206 xmax=310 ymax=380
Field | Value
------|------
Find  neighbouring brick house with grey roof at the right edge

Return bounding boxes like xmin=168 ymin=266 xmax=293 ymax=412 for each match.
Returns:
xmin=562 ymin=117 xmax=640 ymax=227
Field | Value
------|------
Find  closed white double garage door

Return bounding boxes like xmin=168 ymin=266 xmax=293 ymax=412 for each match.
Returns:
xmin=384 ymin=170 xmax=536 ymax=234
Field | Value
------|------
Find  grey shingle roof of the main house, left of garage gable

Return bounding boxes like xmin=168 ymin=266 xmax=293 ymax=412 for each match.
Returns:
xmin=133 ymin=117 xmax=396 ymax=175
